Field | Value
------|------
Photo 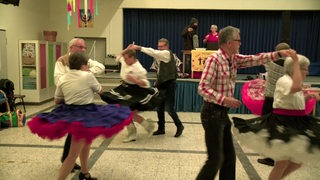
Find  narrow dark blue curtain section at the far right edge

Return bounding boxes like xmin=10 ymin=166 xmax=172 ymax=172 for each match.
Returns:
xmin=290 ymin=11 xmax=320 ymax=76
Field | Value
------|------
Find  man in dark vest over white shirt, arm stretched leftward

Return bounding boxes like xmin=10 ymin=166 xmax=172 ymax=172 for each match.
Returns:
xmin=129 ymin=38 xmax=184 ymax=137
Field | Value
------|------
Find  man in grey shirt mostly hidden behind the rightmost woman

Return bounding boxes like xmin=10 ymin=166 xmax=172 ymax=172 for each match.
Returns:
xmin=257 ymin=43 xmax=290 ymax=166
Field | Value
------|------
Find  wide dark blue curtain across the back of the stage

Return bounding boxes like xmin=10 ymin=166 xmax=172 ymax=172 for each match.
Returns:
xmin=124 ymin=9 xmax=281 ymax=74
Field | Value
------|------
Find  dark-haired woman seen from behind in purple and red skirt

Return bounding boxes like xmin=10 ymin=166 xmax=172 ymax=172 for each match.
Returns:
xmin=28 ymin=52 xmax=132 ymax=180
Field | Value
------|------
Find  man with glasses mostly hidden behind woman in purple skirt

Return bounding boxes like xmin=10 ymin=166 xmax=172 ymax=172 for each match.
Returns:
xmin=54 ymin=38 xmax=105 ymax=172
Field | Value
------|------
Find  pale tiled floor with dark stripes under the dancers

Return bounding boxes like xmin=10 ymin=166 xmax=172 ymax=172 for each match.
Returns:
xmin=0 ymin=100 xmax=320 ymax=180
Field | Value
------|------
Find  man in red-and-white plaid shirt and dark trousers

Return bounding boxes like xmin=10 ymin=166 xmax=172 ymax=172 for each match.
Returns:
xmin=197 ymin=26 xmax=288 ymax=180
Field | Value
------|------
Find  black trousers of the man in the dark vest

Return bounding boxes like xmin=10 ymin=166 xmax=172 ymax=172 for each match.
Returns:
xmin=157 ymin=80 xmax=182 ymax=130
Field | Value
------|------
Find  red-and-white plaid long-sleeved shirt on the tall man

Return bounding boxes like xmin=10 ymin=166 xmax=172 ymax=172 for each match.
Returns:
xmin=198 ymin=49 xmax=278 ymax=105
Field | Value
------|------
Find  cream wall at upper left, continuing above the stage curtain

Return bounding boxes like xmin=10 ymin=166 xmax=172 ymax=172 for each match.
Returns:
xmin=0 ymin=0 xmax=320 ymax=95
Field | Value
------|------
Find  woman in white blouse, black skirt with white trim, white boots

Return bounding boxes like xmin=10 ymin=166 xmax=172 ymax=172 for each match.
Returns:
xmin=100 ymin=48 xmax=160 ymax=143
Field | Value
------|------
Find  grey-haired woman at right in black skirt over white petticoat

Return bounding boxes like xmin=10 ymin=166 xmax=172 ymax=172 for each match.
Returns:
xmin=232 ymin=50 xmax=320 ymax=180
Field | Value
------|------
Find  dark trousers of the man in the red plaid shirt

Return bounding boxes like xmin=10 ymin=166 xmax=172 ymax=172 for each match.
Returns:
xmin=197 ymin=102 xmax=236 ymax=180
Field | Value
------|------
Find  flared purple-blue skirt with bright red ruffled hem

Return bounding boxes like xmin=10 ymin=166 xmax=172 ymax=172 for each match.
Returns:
xmin=27 ymin=104 xmax=132 ymax=143
